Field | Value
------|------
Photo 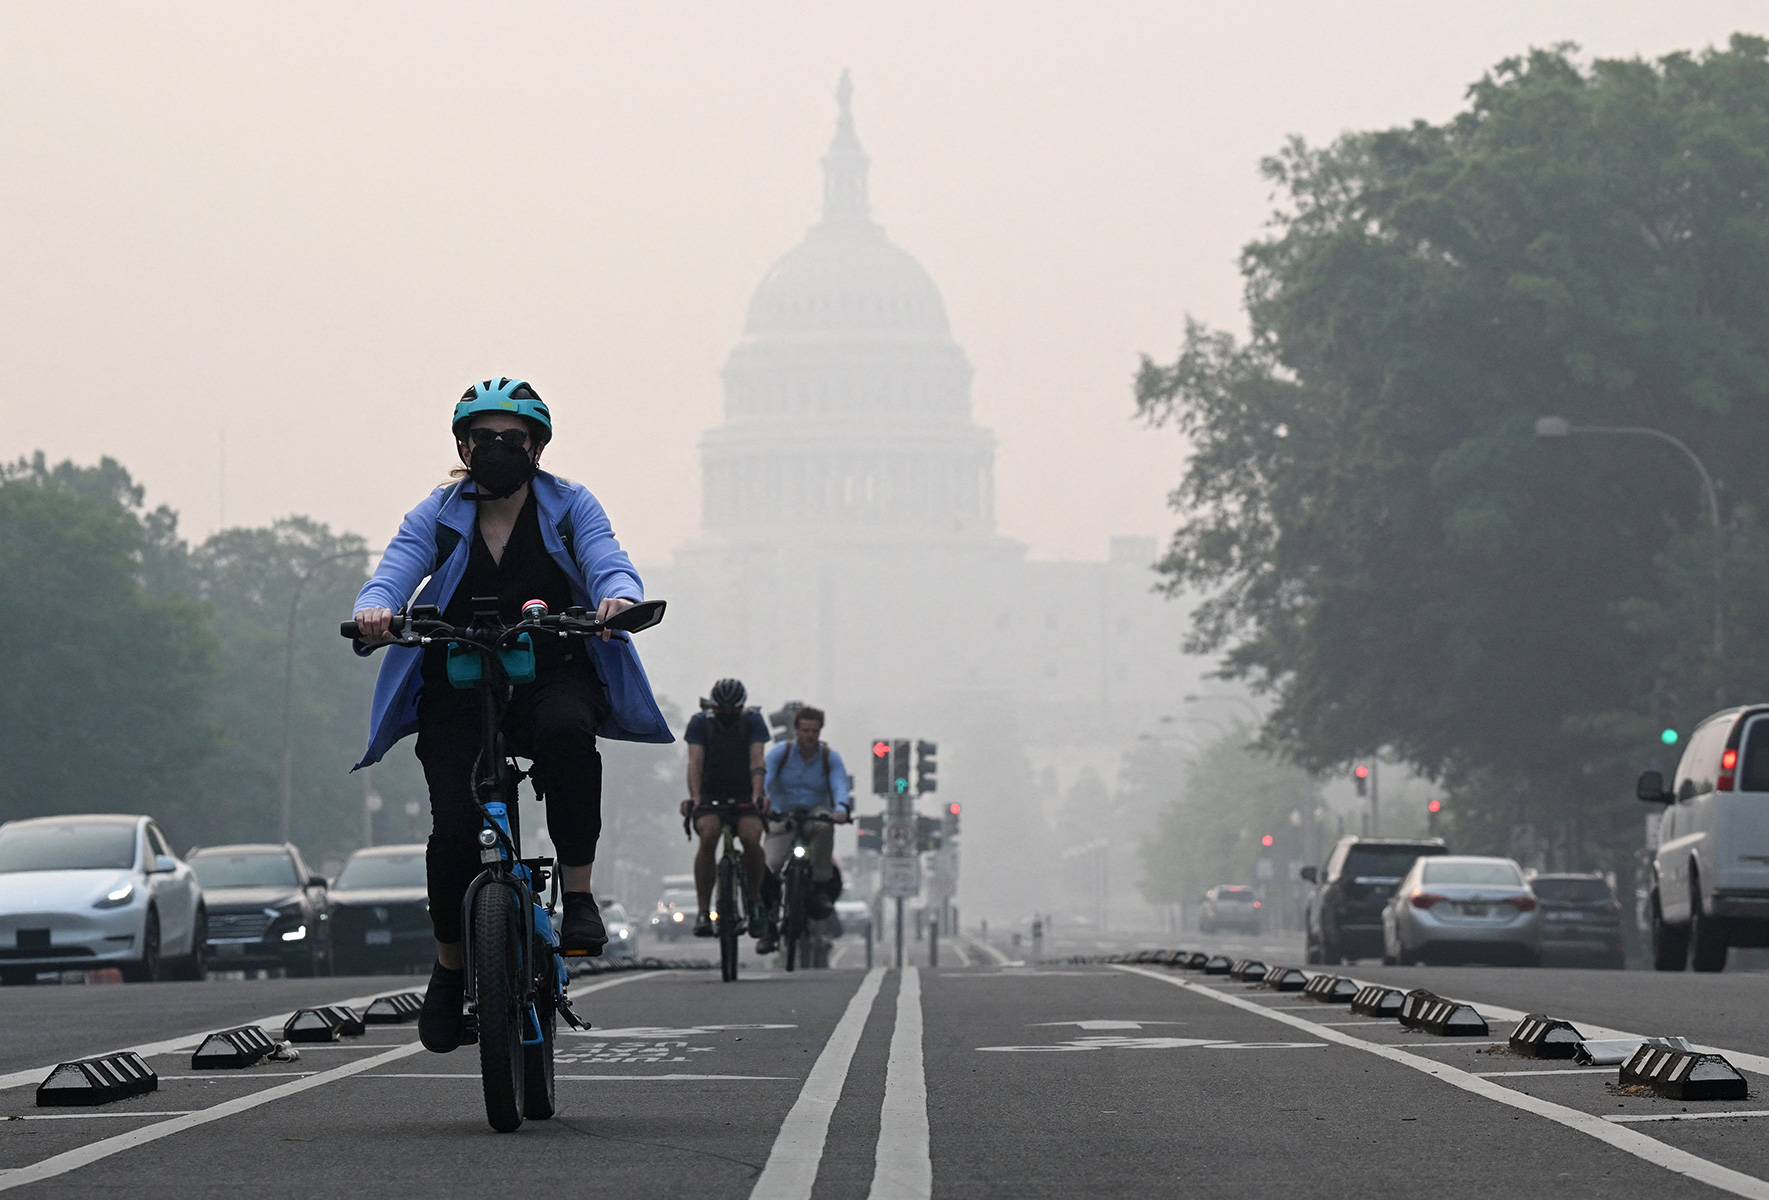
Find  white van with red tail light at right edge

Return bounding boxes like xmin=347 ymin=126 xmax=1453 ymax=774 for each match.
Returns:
xmin=1636 ymin=704 xmax=1769 ymax=972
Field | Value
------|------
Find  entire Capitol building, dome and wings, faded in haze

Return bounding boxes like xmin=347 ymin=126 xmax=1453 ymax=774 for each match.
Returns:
xmin=644 ymin=74 xmax=1208 ymax=903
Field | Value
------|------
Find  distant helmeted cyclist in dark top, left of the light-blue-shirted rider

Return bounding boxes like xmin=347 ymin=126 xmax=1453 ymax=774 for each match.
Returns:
xmin=681 ymin=680 xmax=768 ymax=938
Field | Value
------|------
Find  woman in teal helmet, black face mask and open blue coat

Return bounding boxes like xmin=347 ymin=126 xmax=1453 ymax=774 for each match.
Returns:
xmin=356 ymin=377 xmax=674 ymax=1053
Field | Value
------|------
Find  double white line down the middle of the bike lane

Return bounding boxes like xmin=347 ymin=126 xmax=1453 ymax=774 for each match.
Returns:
xmin=750 ymin=966 xmax=934 ymax=1200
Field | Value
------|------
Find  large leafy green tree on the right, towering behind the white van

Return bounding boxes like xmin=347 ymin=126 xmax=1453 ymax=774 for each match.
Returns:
xmin=1137 ymin=35 xmax=1769 ymax=864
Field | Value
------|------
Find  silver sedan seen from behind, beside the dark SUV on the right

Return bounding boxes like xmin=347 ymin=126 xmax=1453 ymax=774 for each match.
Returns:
xmin=1382 ymin=855 xmax=1543 ymax=966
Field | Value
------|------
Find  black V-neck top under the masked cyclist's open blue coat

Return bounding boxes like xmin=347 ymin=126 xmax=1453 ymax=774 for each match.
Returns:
xmin=425 ymin=488 xmax=594 ymax=697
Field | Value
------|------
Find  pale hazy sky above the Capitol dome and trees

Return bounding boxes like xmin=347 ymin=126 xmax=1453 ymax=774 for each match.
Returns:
xmin=0 ymin=0 xmax=1769 ymax=563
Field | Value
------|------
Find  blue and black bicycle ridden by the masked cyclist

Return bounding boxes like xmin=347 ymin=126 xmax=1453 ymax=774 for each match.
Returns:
xmin=338 ymin=596 xmax=663 ymax=1133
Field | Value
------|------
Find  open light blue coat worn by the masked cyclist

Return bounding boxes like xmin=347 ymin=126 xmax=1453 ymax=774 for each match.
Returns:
xmin=356 ymin=471 xmax=676 ymax=768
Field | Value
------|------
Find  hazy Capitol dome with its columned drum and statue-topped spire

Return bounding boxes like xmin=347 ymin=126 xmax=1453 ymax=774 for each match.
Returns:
xmin=701 ymin=73 xmax=994 ymax=542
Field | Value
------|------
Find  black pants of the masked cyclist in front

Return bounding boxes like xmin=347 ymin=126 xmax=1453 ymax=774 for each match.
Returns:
xmin=417 ymin=662 xmax=609 ymax=942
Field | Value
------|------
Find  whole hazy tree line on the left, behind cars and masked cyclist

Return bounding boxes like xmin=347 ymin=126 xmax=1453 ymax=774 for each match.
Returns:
xmin=0 ymin=453 xmax=681 ymax=871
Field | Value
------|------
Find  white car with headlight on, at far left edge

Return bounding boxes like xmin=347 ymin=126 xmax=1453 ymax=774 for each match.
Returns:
xmin=0 ymin=814 xmax=205 ymax=984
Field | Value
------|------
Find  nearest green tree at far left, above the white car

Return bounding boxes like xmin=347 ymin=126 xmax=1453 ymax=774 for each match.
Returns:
xmin=0 ymin=455 xmax=216 ymax=819
